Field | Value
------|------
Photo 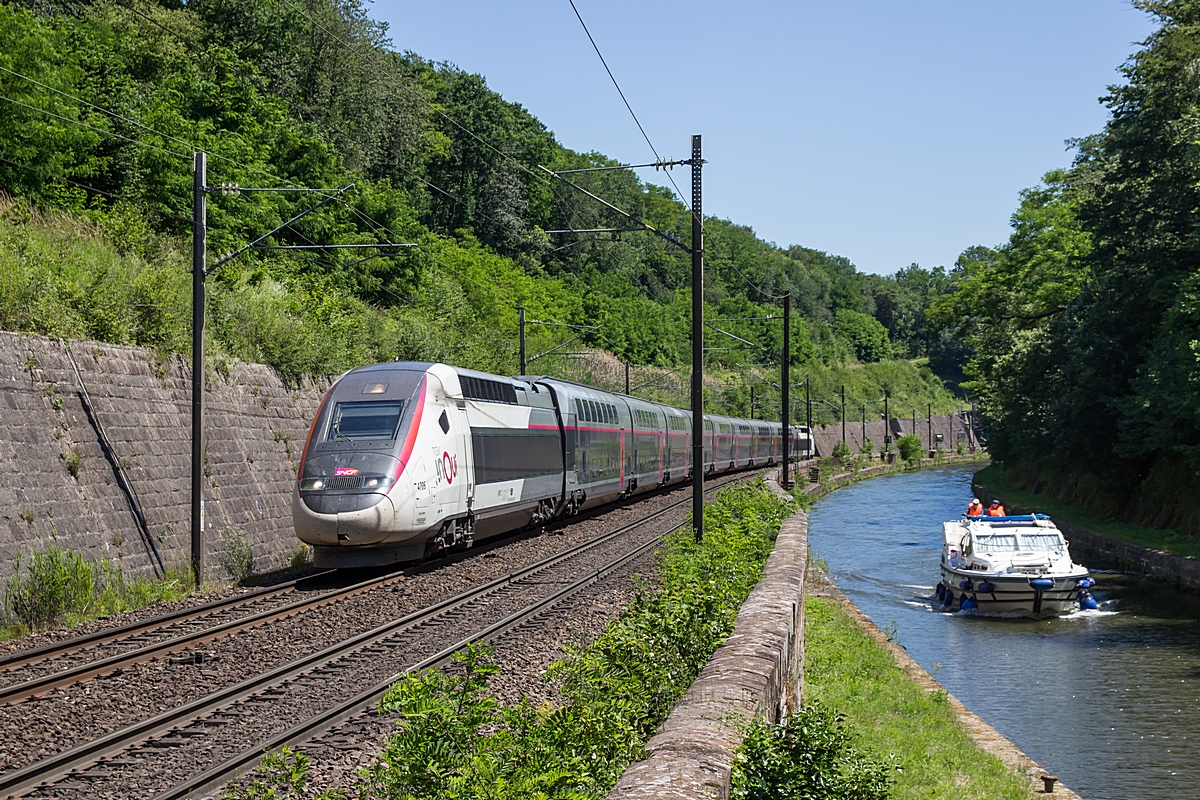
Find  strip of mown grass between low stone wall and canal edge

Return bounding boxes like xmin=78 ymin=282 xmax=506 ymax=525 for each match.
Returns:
xmin=804 ymin=597 xmax=1036 ymax=800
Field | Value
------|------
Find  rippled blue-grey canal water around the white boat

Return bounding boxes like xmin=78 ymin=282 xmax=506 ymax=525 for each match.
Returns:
xmin=809 ymin=467 xmax=1200 ymax=800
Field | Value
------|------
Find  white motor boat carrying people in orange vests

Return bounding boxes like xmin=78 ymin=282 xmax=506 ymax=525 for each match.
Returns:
xmin=937 ymin=513 xmax=1096 ymax=616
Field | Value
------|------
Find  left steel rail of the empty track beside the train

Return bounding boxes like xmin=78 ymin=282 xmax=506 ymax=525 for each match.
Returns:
xmin=0 ymin=474 xmax=724 ymax=798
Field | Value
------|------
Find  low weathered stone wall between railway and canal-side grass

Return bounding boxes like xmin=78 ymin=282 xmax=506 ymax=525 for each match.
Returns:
xmin=608 ymin=479 xmax=809 ymax=800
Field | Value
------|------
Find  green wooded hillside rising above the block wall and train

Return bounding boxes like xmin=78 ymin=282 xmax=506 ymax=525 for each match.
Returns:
xmin=0 ymin=0 xmax=962 ymax=419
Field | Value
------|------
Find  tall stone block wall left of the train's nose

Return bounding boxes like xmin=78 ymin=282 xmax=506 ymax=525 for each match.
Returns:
xmin=0 ymin=332 xmax=325 ymax=579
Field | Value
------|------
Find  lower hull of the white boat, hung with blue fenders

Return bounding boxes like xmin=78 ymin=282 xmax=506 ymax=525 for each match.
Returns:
xmin=935 ymin=564 xmax=1087 ymax=616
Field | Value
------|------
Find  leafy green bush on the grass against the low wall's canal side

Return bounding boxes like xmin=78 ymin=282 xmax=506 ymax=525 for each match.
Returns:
xmin=731 ymin=705 xmax=889 ymax=800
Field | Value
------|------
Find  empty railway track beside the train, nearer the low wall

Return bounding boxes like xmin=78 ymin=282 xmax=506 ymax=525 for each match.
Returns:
xmin=0 ymin=477 xmax=737 ymax=798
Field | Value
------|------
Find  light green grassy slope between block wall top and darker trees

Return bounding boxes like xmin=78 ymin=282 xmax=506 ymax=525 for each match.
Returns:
xmin=0 ymin=197 xmax=956 ymax=419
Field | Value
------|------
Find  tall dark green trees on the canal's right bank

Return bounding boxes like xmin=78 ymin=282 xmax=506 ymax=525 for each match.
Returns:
xmin=932 ymin=0 xmax=1200 ymax=534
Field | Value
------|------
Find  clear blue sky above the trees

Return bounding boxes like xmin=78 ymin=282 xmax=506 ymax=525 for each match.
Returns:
xmin=368 ymin=0 xmax=1153 ymax=273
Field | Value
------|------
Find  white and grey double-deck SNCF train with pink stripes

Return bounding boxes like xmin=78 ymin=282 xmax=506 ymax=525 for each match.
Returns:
xmin=292 ymin=362 xmax=811 ymax=567
